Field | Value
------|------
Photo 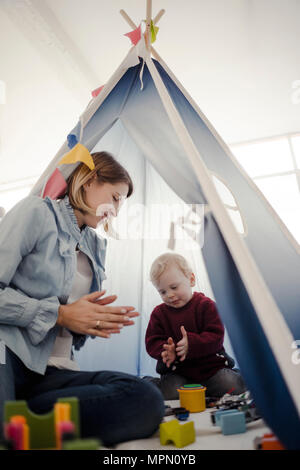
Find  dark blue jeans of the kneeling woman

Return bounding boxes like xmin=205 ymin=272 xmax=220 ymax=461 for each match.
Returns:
xmin=0 ymin=348 xmax=165 ymax=446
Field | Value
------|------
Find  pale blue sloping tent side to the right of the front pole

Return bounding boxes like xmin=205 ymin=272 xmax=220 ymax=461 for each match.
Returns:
xmin=155 ymin=58 xmax=300 ymax=330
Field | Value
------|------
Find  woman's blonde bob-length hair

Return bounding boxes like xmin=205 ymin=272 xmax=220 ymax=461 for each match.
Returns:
xmin=66 ymin=151 xmax=133 ymax=215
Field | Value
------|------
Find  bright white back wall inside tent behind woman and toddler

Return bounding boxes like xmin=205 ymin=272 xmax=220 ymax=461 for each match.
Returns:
xmin=68 ymin=121 xmax=234 ymax=376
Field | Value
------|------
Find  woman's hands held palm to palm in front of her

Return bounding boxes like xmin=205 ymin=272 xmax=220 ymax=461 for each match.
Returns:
xmin=57 ymin=291 xmax=139 ymax=338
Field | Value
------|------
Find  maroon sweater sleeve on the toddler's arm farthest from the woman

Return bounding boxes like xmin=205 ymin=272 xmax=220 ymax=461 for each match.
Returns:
xmin=186 ymin=298 xmax=224 ymax=359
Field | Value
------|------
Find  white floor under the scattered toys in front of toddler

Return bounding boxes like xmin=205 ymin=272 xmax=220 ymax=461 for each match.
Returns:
xmin=102 ymin=400 xmax=270 ymax=450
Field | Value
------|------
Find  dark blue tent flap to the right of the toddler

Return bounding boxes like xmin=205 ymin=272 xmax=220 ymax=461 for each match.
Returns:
xmin=202 ymin=214 xmax=300 ymax=449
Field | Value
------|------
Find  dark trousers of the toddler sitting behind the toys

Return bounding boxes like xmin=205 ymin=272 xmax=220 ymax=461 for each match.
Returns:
xmin=157 ymin=368 xmax=247 ymax=400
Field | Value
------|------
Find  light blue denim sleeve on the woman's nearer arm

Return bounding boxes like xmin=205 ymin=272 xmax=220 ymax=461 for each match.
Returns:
xmin=0 ymin=196 xmax=60 ymax=345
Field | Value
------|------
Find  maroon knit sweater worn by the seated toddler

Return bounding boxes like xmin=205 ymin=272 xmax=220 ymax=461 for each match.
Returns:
xmin=146 ymin=292 xmax=226 ymax=383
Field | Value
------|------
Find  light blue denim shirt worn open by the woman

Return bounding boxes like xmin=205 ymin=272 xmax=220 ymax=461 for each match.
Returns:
xmin=0 ymin=196 xmax=107 ymax=374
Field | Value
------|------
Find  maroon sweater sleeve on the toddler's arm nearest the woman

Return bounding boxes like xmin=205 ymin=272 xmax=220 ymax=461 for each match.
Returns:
xmin=145 ymin=307 xmax=169 ymax=360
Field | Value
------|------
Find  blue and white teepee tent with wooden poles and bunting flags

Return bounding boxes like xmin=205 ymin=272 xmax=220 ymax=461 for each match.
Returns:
xmin=32 ymin=0 xmax=300 ymax=449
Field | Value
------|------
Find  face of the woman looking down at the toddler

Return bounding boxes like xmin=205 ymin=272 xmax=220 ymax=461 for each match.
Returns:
xmin=80 ymin=179 xmax=129 ymax=228
